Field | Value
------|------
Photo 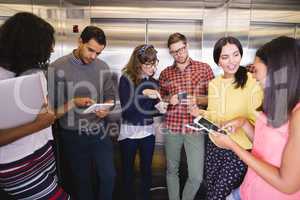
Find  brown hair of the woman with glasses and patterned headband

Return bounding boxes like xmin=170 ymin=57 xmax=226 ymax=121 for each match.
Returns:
xmin=122 ymin=44 xmax=157 ymax=85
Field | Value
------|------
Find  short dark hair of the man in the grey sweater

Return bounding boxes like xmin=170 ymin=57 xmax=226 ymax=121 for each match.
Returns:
xmin=80 ymin=26 xmax=106 ymax=46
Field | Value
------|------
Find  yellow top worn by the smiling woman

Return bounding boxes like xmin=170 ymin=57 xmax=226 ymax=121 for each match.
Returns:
xmin=204 ymin=73 xmax=263 ymax=149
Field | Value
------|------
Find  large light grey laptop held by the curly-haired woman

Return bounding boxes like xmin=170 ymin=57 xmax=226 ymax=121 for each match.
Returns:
xmin=0 ymin=73 xmax=47 ymax=129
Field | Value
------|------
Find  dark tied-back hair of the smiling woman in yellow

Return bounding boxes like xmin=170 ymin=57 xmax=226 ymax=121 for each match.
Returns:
xmin=213 ymin=36 xmax=248 ymax=88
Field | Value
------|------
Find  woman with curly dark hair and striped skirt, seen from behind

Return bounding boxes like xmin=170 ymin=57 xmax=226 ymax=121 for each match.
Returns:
xmin=0 ymin=12 xmax=70 ymax=199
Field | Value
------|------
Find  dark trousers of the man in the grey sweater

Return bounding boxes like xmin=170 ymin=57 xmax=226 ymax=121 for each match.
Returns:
xmin=59 ymin=129 xmax=115 ymax=200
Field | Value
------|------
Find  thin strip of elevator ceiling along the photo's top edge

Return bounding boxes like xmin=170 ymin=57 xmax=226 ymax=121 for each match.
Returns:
xmin=0 ymin=0 xmax=300 ymax=10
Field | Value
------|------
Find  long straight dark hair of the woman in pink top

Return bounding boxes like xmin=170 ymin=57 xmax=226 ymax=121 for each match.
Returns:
xmin=256 ymin=36 xmax=300 ymax=127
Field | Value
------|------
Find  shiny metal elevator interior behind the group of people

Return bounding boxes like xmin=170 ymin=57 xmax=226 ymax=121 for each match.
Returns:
xmin=0 ymin=0 xmax=300 ymax=198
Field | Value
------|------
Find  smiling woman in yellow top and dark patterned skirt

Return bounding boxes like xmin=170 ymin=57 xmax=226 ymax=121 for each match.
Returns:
xmin=191 ymin=37 xmax=262 ymax=200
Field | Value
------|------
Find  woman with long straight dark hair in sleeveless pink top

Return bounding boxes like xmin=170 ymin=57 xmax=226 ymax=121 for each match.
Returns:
xmin=212 ymin=36 xmax=300 ymax=200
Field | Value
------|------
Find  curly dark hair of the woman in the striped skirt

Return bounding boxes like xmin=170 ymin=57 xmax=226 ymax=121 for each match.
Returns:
xmin=0 ymin=12 xmax=55 ymax=75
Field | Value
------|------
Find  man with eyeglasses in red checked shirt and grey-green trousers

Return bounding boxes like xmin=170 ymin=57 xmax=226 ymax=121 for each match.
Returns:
xmin=159 ymin=33 xmax=214 ymax=200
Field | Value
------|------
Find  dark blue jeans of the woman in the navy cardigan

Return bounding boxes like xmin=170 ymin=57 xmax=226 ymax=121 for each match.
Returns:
xmin=120 ymin=135 xmax=155 ymax=200
